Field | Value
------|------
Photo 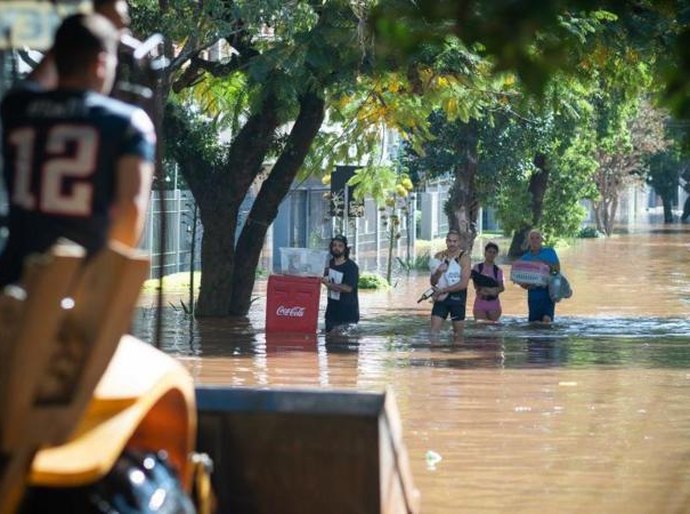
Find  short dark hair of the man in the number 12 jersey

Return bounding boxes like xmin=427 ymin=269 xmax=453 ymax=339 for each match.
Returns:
xmin=53 ymin=14 xmax=119 ymax=77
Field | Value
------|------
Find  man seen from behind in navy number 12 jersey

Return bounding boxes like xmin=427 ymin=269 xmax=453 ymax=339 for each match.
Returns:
xmin=0 ymin=14 xmax=155 ymax=286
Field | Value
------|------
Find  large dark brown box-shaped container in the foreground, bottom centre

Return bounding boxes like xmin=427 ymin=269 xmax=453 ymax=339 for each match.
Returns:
xmin=197 ymin=387 xmax=419 ymax=514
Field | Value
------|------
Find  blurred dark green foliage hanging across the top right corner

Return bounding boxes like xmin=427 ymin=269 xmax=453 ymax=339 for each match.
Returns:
xmin=371 ymin=0 xmax=690 ymax=134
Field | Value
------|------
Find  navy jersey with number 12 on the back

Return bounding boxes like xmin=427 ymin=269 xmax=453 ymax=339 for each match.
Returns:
xmin=0 ymin=83 xmax=155 ymax=285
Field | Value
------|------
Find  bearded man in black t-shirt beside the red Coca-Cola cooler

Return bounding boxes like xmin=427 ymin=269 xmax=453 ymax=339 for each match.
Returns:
xmin=321 ymin=235 xmax=359 ymax=332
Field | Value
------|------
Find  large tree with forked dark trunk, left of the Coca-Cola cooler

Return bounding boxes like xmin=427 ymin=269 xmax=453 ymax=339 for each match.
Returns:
xmin=132 ymin=0 xmax=382 ymax=316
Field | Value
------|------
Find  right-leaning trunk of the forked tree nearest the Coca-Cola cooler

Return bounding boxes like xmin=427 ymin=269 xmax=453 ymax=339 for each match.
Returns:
xmin=228 ymin=93 xmax=325 ymax=316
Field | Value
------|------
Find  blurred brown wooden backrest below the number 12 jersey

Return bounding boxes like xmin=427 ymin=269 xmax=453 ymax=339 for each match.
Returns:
xmin=0 ymin=241 xmax=148 ymax=514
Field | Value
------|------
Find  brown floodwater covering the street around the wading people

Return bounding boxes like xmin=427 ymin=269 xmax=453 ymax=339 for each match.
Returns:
xmin=135 ymin=226 xmax=690 ymax=514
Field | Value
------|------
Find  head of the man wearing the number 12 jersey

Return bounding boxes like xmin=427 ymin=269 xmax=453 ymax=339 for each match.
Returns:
xmin=53 ymin=14 xmax=119 ymax=94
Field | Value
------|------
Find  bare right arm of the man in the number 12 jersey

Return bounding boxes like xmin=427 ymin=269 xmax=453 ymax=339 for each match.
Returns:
xmin=109 ymin=155 xmax=153 ymax=247
